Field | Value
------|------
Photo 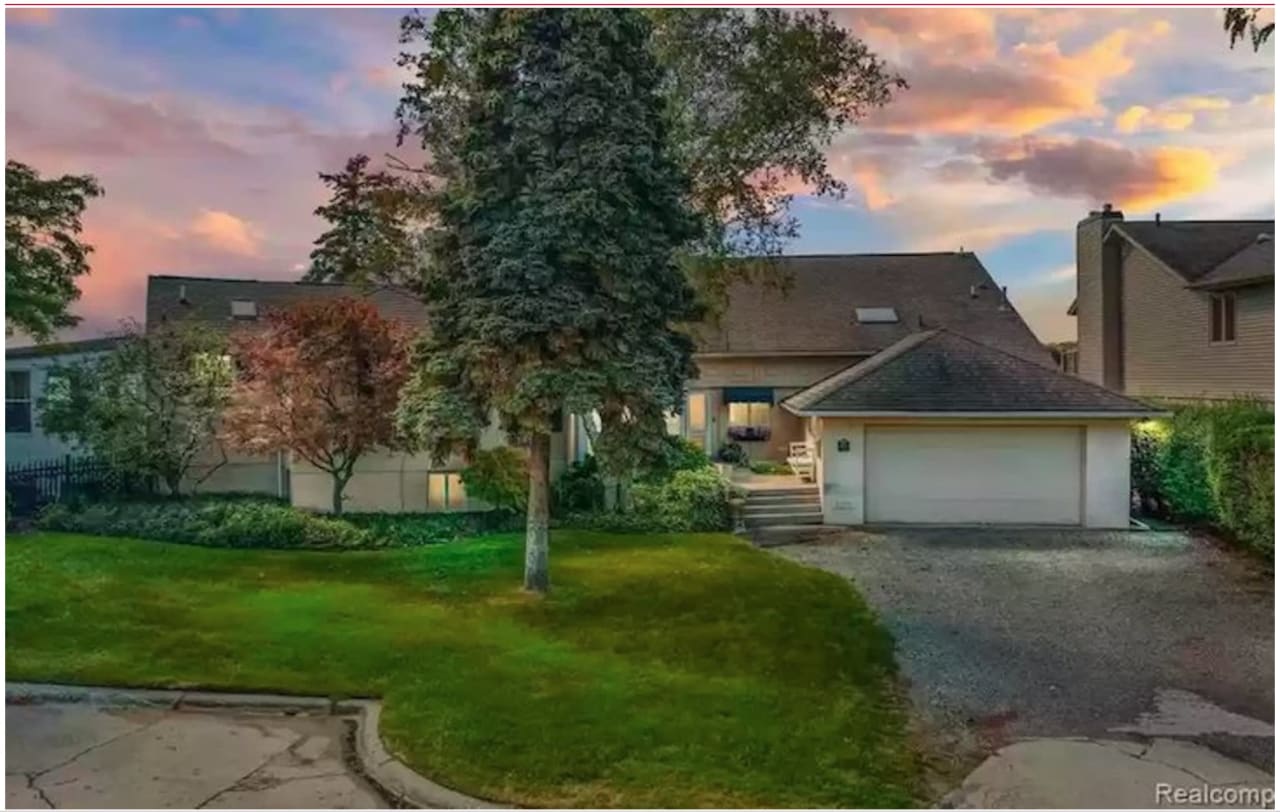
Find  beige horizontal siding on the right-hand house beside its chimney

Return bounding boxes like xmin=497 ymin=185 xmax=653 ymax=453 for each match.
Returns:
xmin=1121 ymin=250 xmax=1275 ymax=400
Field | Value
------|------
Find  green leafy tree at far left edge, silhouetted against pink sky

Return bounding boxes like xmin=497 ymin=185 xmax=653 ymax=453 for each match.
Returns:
xmin=4 ymin=160 xmax=102 ymax=341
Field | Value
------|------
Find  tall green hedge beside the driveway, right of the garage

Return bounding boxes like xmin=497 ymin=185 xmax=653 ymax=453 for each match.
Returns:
xmin=1133 ymin=401 xmax=1275 ymax=556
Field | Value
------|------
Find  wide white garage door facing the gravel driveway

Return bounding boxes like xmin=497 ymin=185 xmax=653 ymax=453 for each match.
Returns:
xmin=865 ymin=426 xmax=1083 ymax=524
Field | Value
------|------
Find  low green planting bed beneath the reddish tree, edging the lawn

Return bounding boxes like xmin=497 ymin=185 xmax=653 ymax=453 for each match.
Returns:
xmin=36 ymin=496 xmax=518 ymax=549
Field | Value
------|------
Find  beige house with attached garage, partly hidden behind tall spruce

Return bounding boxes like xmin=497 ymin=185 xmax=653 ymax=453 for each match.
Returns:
xmin=147 ymin=252 xmax=1155 ymax=526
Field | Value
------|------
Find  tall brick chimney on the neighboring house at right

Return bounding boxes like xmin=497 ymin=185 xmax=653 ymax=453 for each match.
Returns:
xmin=1075 ymin=204 xmax=1124 ymax=389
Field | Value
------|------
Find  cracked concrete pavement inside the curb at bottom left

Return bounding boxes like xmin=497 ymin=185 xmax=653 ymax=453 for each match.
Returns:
xmin=5 ymin=704 xmax=388 ymax=809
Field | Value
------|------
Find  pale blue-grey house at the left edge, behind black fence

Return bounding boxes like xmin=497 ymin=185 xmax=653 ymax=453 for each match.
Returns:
xmin=4 ymin=338 xmax=120 ymax=466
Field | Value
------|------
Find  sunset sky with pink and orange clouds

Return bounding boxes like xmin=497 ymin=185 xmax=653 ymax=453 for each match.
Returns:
xmin=5 ymin=8 xmax=1275 ymax=343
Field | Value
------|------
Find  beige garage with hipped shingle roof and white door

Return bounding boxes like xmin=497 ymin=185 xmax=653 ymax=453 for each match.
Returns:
xmin=782 ymin=328 xmax=1164 ymax=528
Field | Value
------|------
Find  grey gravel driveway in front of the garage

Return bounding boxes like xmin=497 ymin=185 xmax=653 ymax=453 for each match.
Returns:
xmin=773 ymin=528 xmax=1275 ymax=770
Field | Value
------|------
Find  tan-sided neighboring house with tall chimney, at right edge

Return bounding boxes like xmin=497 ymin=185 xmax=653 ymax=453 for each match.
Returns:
xmin=1068 ymin=205 xmax=1275 ymax=402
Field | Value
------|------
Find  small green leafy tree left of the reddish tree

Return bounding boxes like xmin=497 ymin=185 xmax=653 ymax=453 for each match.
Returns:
xmin=37 ymin=324 xmax=232 ymax=494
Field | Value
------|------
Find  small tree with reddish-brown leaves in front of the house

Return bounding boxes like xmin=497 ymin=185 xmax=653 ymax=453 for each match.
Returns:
xmin=223 ymin=297 xmax=412 ymax=514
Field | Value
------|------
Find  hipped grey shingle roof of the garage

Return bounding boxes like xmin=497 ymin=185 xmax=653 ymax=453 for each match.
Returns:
xmin=782 ymin=329 xmax=1160 ymax=418
